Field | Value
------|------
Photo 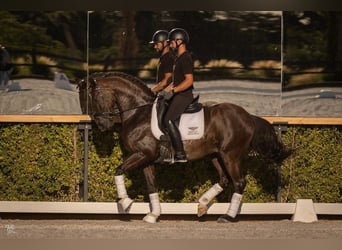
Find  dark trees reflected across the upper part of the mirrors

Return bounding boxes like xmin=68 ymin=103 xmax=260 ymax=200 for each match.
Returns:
xmin=0 ymin=11 xmax=342 ymax=85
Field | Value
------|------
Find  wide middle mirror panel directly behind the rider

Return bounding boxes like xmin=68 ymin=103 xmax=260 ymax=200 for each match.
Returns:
xmin=89 ymin=11 xmax=281 ymax=115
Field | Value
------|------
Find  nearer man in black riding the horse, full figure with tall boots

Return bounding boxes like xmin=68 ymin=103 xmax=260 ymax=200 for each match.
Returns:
xmin=162 ymin=28 xmax=194 ymax=162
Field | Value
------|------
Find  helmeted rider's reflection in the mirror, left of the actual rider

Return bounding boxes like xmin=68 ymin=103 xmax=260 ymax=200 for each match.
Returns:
xmin=150 ymin=30 xmax=175 ymax=94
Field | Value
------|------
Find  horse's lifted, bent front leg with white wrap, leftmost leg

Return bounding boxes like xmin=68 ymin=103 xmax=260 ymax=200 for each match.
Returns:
xmin=114 ymin=152 xmax=145 ymax=212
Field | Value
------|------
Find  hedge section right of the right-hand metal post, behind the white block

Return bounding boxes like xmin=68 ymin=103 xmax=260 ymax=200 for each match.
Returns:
xmin=282 ymin=127 xmax=342 ymax=202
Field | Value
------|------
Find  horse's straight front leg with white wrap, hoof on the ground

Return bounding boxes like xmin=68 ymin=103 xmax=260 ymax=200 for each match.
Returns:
xmin=143 ymin=165 xmax=161 ymax=223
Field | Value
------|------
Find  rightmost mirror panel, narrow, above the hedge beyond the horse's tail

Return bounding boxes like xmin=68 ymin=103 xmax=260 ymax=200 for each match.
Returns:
xmin=281 ymin=11 xmax=342 ymax=117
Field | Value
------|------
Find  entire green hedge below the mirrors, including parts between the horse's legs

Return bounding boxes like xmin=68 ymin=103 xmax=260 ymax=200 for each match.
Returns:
xmin=0 ymin=124 xmax=342 ymax=202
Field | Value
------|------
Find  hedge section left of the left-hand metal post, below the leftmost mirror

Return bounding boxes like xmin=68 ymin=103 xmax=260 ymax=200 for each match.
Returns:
xmin=0 ymin=124 xmax=81 ymax=201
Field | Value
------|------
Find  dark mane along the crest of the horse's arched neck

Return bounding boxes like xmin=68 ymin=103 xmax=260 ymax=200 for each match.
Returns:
xmin=90 ymin=71 xmax=153 ymax=96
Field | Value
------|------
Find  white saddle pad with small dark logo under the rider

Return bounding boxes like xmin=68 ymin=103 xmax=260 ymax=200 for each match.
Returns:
xmin=151 ymin=100 xmax=204 ymax=141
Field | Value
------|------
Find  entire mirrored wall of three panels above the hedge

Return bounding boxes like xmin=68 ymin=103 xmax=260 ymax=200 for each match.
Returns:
xmin=0 ymin=11 xmax=342 ymax=117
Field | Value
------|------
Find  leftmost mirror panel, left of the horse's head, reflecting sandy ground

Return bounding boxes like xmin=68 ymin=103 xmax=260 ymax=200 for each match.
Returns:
xmin=0 ymin=11 xmax=87 ymax=115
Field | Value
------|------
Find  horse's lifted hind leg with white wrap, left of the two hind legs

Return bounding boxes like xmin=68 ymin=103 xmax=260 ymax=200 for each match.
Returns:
xmin=197 ymin=157 xmax=228 ymax=217
